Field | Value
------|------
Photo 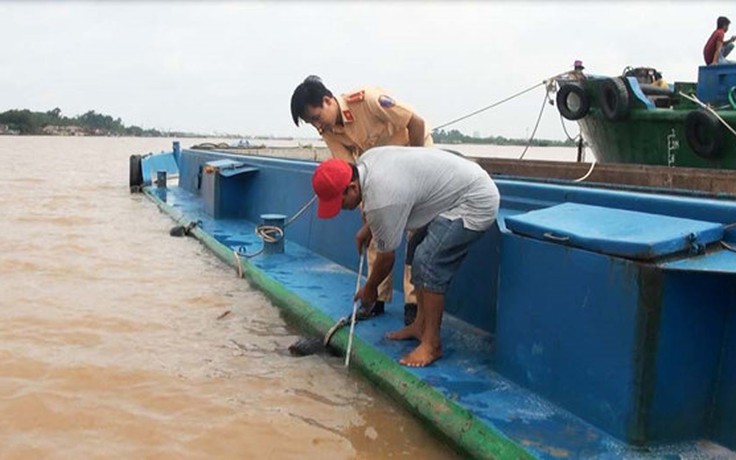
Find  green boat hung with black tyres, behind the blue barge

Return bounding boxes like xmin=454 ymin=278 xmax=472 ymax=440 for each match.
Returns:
xmin=556 ymin=64 xmax=736 ymax=169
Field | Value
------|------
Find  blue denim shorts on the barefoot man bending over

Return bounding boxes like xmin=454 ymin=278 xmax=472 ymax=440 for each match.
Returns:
xmin=406 ymin=217 xmax=485 ymax=293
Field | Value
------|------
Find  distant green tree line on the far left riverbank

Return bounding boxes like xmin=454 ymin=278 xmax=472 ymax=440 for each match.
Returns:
xmin=0 ymin=107 xmax=163 ymax=137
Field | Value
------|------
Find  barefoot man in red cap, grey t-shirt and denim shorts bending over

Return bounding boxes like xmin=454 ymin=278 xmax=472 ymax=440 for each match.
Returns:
xmin=312 ymin=146 xmax=499 ymax=367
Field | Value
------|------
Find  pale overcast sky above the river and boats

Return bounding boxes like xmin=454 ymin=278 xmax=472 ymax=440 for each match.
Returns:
xmin=0 ymin=0 xmax=736 ymax=139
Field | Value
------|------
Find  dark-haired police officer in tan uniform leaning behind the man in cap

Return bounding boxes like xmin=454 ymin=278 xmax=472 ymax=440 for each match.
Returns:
xmin=291 ymin=75 xmax=432 ymax=325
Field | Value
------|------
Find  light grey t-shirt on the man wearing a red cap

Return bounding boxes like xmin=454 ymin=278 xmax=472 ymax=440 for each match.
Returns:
xmin=357 ymin=146 xmax=499 ymax=252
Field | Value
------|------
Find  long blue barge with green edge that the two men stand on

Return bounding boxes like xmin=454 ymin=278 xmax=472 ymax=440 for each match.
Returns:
xmin=131 ymin=143 xmax=736 ymax=459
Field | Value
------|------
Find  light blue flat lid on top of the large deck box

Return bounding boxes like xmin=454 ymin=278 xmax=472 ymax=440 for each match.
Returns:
xmin=505 ymin=203 xmax=723 ymax=260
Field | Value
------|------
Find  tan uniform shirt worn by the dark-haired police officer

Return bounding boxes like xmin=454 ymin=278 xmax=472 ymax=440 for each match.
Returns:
xmin=321 ymin=87 xmax=432 ymax=163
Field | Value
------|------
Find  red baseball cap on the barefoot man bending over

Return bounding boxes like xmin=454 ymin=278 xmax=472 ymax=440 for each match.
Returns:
xmin=312 ymin=158 xmax=353 ymax=219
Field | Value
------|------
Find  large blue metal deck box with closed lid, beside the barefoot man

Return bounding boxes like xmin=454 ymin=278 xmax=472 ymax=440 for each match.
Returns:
xmin=495 ymin=203 xmax=736 ymax=445
